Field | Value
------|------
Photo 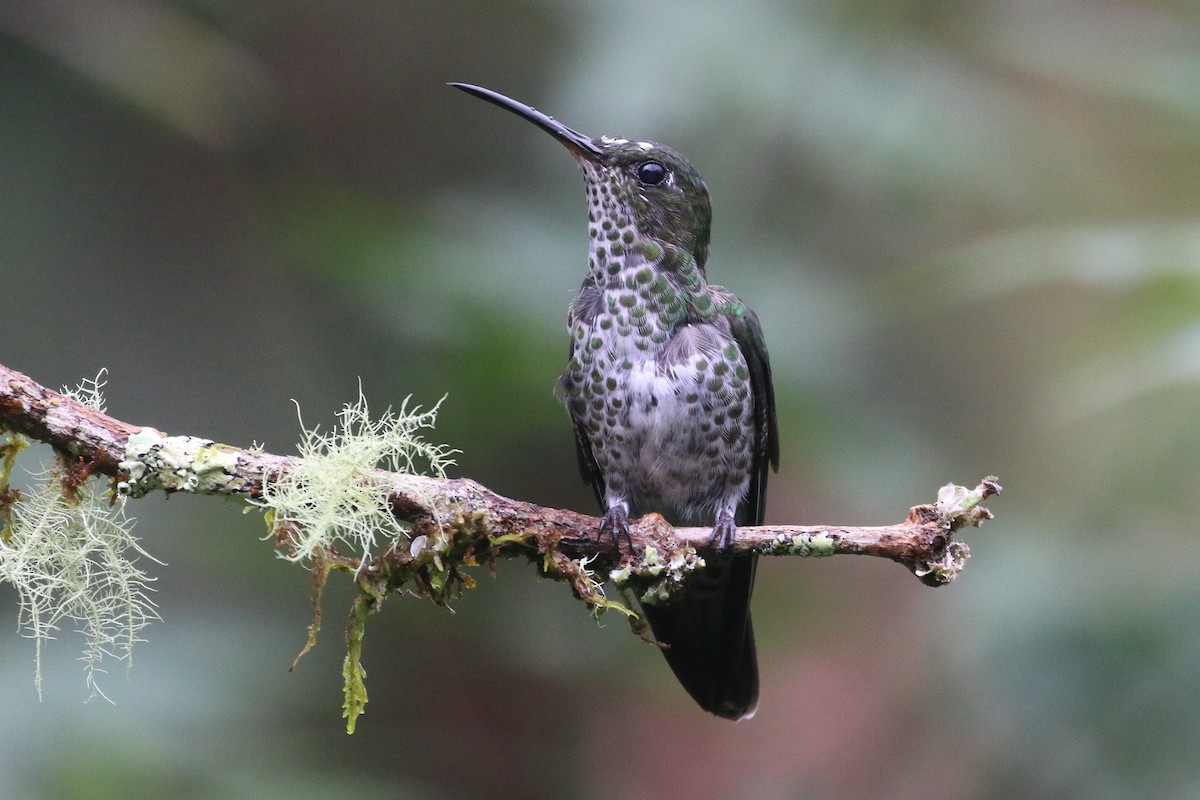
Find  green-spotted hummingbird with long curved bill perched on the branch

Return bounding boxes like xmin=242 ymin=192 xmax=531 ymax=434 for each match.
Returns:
xmin=450 ymin=83 xmax=779 ymax=720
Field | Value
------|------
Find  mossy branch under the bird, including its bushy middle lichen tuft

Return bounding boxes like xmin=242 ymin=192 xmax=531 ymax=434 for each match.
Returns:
xmin=0 ymin=365 xmax=1001 ymax=732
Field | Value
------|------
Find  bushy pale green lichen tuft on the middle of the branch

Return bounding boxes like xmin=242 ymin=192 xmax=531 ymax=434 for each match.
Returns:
xmin=253 ymin=390 xmax=456 ymax=561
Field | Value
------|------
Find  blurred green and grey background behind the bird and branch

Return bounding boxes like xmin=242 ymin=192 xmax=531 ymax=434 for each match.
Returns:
xmin=0 ymin=0 xmax=1200 ymax=800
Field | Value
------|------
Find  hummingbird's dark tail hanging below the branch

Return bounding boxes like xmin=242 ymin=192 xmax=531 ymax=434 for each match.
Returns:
xmin=642 ymin=555 xmax=758 ymax=720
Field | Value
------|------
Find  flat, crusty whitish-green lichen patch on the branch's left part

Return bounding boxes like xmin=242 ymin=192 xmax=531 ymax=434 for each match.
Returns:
xmin=116 ymin=427 xmax=245 ymax=498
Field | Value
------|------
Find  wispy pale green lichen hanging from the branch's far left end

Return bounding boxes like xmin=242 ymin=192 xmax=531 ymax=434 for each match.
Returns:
xmin=0 ymin=372 xmax=158 ymax=699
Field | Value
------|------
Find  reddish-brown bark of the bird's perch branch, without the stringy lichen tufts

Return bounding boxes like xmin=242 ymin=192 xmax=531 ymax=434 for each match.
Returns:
xmin=0 ymin=365 xmax=1001 ymax=587
